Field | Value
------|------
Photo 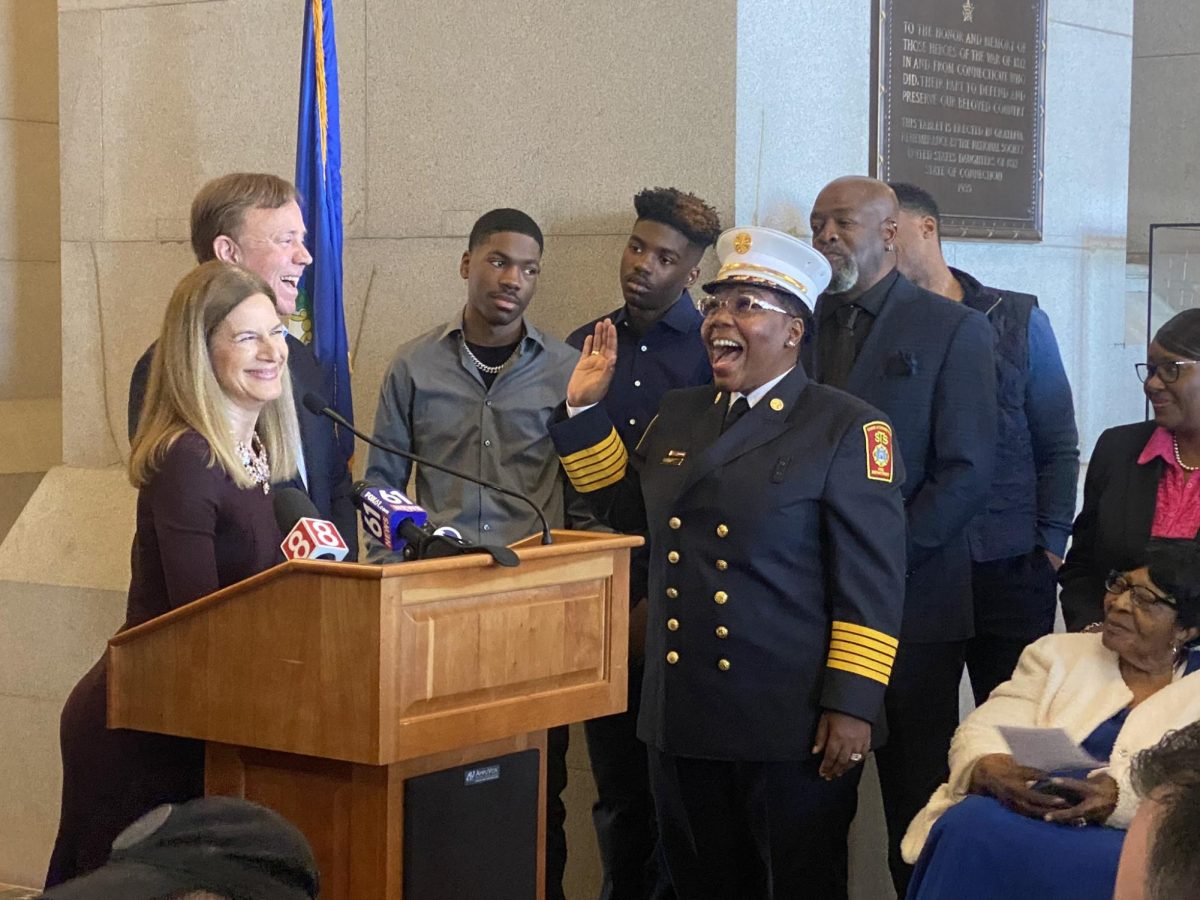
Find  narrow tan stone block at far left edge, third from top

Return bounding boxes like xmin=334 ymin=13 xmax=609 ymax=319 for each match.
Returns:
xmin=0 ymin=259 xmax=62 ymax=400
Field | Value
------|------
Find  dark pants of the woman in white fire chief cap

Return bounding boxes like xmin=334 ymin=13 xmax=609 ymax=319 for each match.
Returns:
xmin=648 ymin=748 xmax=862 ymax=900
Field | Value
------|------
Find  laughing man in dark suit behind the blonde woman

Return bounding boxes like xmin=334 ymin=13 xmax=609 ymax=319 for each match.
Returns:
xmin=128 ymin=172 xmax=359 ymax=559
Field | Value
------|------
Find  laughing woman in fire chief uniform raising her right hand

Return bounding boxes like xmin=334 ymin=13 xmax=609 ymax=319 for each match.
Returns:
xmin=552 ymin=228 xmax=905 ymax=900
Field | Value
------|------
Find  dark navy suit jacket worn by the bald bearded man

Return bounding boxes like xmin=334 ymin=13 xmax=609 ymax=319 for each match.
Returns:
xmin=804 ymin=275 xmax=997 ymax=642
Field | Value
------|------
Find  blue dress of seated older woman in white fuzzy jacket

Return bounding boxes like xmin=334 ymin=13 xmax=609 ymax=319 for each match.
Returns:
xmin=906 ymin=653 xmax=1200 ymax=900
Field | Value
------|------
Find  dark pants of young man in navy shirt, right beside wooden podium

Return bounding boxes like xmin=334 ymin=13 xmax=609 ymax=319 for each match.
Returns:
xmin=583 ymin=662 xmax=674 ymax=900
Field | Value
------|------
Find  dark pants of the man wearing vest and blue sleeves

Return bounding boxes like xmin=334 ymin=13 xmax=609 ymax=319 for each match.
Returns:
xmin=966 ymin=547 xmax=1058 ymax=706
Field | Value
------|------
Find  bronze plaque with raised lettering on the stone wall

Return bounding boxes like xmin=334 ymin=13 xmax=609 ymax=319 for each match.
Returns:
xmin=871 ymin=0 xmax=1046 ymax=240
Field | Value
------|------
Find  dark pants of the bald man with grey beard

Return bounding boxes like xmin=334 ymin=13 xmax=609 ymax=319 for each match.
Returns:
xmin=875 ymin=641 xmax=966 ymax=896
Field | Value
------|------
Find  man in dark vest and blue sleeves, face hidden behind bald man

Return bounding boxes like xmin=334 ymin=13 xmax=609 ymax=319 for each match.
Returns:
xmin=892 ymin=184 xmax=1079 ymax=703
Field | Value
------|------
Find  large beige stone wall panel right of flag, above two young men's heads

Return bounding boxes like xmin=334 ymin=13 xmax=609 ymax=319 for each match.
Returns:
xmin=366 ymin=0 xmax=736 ymax=238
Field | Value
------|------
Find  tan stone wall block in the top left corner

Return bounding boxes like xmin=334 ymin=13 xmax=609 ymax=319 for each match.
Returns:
xmin=0 ymin=0 xmax=59 ymax=124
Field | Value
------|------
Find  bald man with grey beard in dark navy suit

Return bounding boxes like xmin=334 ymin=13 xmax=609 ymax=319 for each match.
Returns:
xmin=804 ymin=176 xmax=996 ymax=896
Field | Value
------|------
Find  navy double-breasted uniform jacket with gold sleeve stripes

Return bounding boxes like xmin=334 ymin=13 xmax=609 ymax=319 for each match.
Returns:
xmin=551 ymin=366 xmax=905 ymax=761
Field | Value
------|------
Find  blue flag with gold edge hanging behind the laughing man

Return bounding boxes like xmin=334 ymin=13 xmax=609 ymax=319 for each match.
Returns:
xmin=296 ymin=0 xmax=354 ymax=458
